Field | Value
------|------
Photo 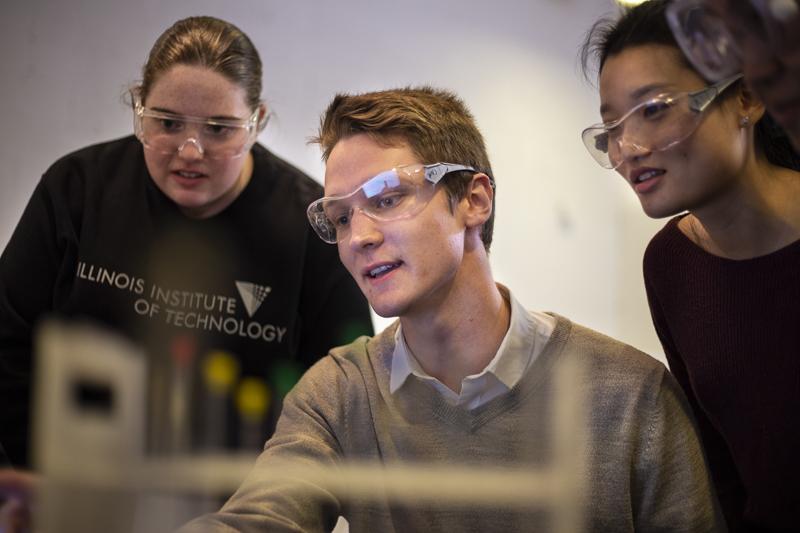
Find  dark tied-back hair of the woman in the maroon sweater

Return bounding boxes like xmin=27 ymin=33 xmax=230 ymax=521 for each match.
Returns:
xmin=580 ymin=0 xmax=800 ymax=170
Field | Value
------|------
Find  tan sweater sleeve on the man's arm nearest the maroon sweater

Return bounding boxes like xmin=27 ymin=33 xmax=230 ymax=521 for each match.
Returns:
xmin=632 ymin=367 xmax=725 ymax=532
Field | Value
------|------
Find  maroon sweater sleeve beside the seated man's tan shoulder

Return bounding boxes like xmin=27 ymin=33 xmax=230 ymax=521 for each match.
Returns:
xmin=645 ymin=272 xmax=745 ymax=531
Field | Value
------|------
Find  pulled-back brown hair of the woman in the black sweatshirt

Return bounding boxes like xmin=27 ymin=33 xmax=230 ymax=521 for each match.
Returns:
xmin=134 ymin=17 xmax=261 ymax=110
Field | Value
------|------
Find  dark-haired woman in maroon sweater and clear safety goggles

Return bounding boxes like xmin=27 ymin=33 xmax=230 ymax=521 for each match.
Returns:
xmin=583 ymin=0 xmax=800 ymax=531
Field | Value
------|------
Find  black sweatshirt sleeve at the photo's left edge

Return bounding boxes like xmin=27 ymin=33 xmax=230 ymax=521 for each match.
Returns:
xmin=0 ymin=172 xmax=77 ymax=466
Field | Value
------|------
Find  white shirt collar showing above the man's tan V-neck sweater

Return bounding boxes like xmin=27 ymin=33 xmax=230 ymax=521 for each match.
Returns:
xmin=389 ymin=284 xmax=556 ymax=409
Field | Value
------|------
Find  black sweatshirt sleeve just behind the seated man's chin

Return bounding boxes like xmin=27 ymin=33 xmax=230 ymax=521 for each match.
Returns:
xmin=298 ymin=233 xmax=373 ymax=367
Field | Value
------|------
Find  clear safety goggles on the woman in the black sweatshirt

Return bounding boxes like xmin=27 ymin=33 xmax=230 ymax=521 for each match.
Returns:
xmin=133 ymin=96 xmax=260 ymax=159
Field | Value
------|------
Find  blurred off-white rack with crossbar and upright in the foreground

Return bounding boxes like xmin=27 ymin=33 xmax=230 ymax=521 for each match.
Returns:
xmin=28 ymin=322 xmax=586 ymax=533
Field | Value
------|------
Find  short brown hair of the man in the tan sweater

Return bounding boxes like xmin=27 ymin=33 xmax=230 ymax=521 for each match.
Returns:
xmin=311 ymin=86 xmax=495 ymax=252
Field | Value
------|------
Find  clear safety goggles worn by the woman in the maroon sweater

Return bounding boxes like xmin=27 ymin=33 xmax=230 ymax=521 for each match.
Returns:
xmin=581 ymin=74 xmax=742 ymax=169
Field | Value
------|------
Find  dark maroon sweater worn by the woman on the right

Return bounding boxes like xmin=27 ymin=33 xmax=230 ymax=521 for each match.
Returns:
xmin=644 ymin=217 xmax=800 ymax=531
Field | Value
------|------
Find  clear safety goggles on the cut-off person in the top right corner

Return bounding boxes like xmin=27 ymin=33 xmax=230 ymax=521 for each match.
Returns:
xmin=666 ymin=0 xmax=798 ymax=82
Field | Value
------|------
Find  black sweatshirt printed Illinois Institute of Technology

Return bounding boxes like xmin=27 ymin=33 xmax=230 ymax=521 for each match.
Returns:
xmin=0 ymin=136 xmax=372 ymax=466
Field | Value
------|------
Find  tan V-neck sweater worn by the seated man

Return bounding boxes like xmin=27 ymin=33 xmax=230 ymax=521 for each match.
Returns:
xmin=181 ymin=317 xmax=724 ymax=533
